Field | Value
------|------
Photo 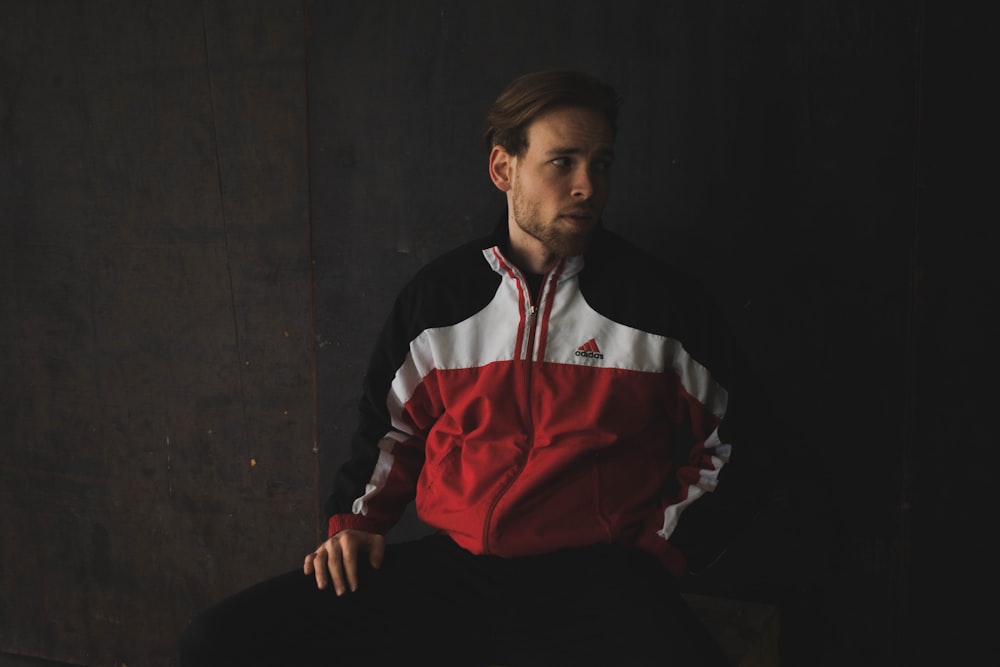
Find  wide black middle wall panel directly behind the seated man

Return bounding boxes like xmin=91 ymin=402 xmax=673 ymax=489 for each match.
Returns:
xmin=309 ymin=0 xmax=976 ymax=665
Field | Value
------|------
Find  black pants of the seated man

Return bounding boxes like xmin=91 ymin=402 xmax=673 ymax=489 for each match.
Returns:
xmin=181 ymin=536 xmax=726 ymax=667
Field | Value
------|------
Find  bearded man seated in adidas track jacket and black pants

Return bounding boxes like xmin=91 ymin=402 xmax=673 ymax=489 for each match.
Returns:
xmin=182 ymin=71 xmax=759 ymax=667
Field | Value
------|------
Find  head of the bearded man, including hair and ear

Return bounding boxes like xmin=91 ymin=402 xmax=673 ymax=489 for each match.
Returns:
xmin=486 ymin=71 xmax=618 ymax=273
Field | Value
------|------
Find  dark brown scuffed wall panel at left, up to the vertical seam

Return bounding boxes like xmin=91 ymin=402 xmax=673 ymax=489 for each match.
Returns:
xmin=0 ymin=0 xmax=316 ymax=667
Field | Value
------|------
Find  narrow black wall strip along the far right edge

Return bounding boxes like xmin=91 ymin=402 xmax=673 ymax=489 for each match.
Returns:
xmin=901 ymin=2 xmax=1000 ymax=664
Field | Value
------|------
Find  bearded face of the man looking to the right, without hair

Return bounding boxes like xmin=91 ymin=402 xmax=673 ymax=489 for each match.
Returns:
xmin=509 ymin=108 xmax=614 ymax=257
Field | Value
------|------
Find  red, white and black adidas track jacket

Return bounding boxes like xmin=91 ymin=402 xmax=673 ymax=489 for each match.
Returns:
xmin=327 ymin=220 xmax=760 ymax=575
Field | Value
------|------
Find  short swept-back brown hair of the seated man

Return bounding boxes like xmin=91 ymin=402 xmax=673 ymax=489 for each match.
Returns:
xmin=483 ymin=69 xmax=621 ymax=156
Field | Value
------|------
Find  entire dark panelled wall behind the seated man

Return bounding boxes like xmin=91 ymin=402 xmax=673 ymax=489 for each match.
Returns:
xmin=0 ymin=0 xmax=984 ymax=667
